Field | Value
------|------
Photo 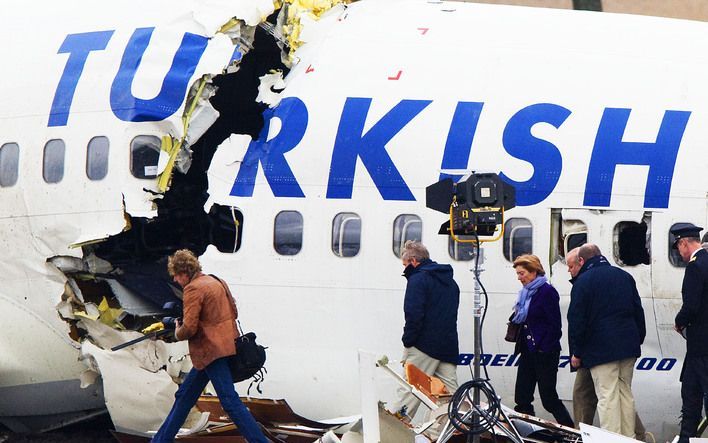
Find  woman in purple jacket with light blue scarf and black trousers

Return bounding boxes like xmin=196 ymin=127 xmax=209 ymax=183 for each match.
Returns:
xmin=511 ymin=255 xmax=573 ymax=427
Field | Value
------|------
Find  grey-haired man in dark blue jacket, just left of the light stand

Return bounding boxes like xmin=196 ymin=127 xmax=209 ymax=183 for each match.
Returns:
xmin=392 ymin=241 xmax=460 ymax=417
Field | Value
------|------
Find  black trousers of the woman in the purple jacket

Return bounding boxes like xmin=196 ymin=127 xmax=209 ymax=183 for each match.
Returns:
xmin=514 ymin=351 xmax=574 ymax=428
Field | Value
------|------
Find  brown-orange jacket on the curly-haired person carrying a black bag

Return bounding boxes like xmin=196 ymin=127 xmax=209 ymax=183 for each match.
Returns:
xmin=175 ymin=273 xmax=239 ymax=370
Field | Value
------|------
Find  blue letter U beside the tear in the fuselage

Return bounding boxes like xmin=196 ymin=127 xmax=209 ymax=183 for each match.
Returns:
xmin=111 ymin=28 xmax=208 ymax=122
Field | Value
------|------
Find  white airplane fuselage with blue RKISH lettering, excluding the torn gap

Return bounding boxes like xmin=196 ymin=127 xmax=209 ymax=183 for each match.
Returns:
xmin=0 ymin=1 xmax=708 ymax=437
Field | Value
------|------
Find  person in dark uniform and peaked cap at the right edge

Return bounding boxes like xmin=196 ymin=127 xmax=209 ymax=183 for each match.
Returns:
xmin=671 ymin=223 xmax=708 ymax=443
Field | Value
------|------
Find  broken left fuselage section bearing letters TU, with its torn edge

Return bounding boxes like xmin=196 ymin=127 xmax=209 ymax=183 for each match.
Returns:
xmin=0 ymin=0 xmax=337 ymax=432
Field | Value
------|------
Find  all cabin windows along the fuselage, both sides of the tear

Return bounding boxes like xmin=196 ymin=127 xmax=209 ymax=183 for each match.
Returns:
xmin=0 ymin=139 xmax=685 ymax=267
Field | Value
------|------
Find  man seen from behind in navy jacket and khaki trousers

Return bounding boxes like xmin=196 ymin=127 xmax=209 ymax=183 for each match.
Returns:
xmin=568 ymin=243 xmax=646 ymax=438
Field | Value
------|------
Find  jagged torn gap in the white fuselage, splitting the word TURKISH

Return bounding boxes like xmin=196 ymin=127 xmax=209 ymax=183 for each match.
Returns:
xmin=33 ymin=0 xmax=343 ymax=433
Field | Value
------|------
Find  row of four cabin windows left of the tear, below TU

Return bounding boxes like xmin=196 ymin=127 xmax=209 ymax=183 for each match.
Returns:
xmin=0 ymin=135 xmax=161 ymax=187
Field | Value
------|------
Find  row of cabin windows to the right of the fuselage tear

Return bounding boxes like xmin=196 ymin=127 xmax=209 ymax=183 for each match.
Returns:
xmin=273 ymin=211 xmax=685 ymax=267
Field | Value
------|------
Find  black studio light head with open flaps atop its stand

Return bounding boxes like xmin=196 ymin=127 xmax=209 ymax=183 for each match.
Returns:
xmin=425 ymin=172 xmax=516 ymax=236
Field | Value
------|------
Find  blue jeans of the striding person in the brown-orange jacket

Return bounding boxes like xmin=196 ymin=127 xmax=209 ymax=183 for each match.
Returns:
xmin=151 ymin=357 xmax=268 ymax=443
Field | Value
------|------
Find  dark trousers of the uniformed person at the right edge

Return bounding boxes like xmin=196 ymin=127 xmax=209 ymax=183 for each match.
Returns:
xmin=679 ymin=355 xmax=708 ymax=443
